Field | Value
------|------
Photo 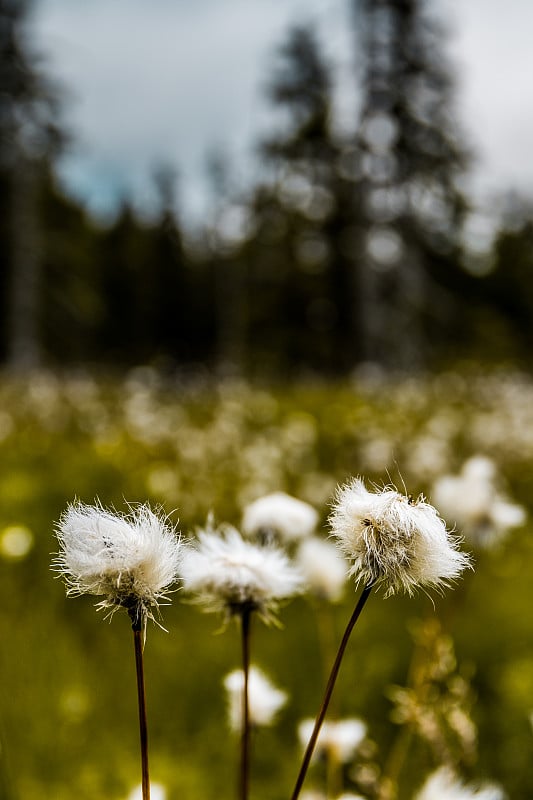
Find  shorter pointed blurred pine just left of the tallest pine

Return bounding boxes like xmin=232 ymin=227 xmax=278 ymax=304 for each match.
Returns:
xmin=252 ymin=26 xmax=360 ymax=373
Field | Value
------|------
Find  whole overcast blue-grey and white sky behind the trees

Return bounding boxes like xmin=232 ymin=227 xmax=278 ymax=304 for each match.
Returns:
xmin=33 ymin=0 xmax=533 ymax=230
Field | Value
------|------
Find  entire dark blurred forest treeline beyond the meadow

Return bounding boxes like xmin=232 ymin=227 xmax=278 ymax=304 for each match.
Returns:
xmin=0 ymin=0 xmax=533 ymax=376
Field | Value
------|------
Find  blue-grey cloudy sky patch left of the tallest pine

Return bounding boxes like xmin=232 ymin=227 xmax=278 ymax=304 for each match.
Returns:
xmin=34 ymin=0 xmax=350 ymax=219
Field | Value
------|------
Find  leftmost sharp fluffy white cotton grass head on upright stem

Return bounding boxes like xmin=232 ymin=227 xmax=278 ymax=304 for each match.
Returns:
xmin=53 ymin=503 xmax=181 ymax=628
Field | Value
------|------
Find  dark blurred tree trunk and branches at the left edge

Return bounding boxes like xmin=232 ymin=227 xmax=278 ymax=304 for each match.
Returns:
xmin=0 ymin=0 xmax=61 ymax=368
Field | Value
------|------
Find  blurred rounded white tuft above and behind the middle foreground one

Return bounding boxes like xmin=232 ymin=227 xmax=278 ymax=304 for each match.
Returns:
xmin=242 ymin=492 xmax=319 ymax=543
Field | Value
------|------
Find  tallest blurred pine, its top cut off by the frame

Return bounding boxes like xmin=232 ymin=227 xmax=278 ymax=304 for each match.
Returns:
xmin=354 ymin=0 xmax=466 ymax=368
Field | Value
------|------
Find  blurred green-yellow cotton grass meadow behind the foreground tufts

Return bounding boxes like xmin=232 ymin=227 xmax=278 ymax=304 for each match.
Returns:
xmin=0 ymin=369 xmax=533 ymax=800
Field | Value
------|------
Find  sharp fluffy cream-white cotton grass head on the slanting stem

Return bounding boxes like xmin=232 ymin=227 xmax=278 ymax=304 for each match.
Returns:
xmin=329 ymin=478 xmax=470 ymax=596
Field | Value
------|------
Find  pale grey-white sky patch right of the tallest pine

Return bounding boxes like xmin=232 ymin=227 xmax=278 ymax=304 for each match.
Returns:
xmin=441 ymin=0 xmax=533 ymax=194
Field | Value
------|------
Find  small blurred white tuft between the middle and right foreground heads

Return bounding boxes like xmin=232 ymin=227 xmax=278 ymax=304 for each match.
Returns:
xmin=296 ymin=536 xmax=348 ymax=602
